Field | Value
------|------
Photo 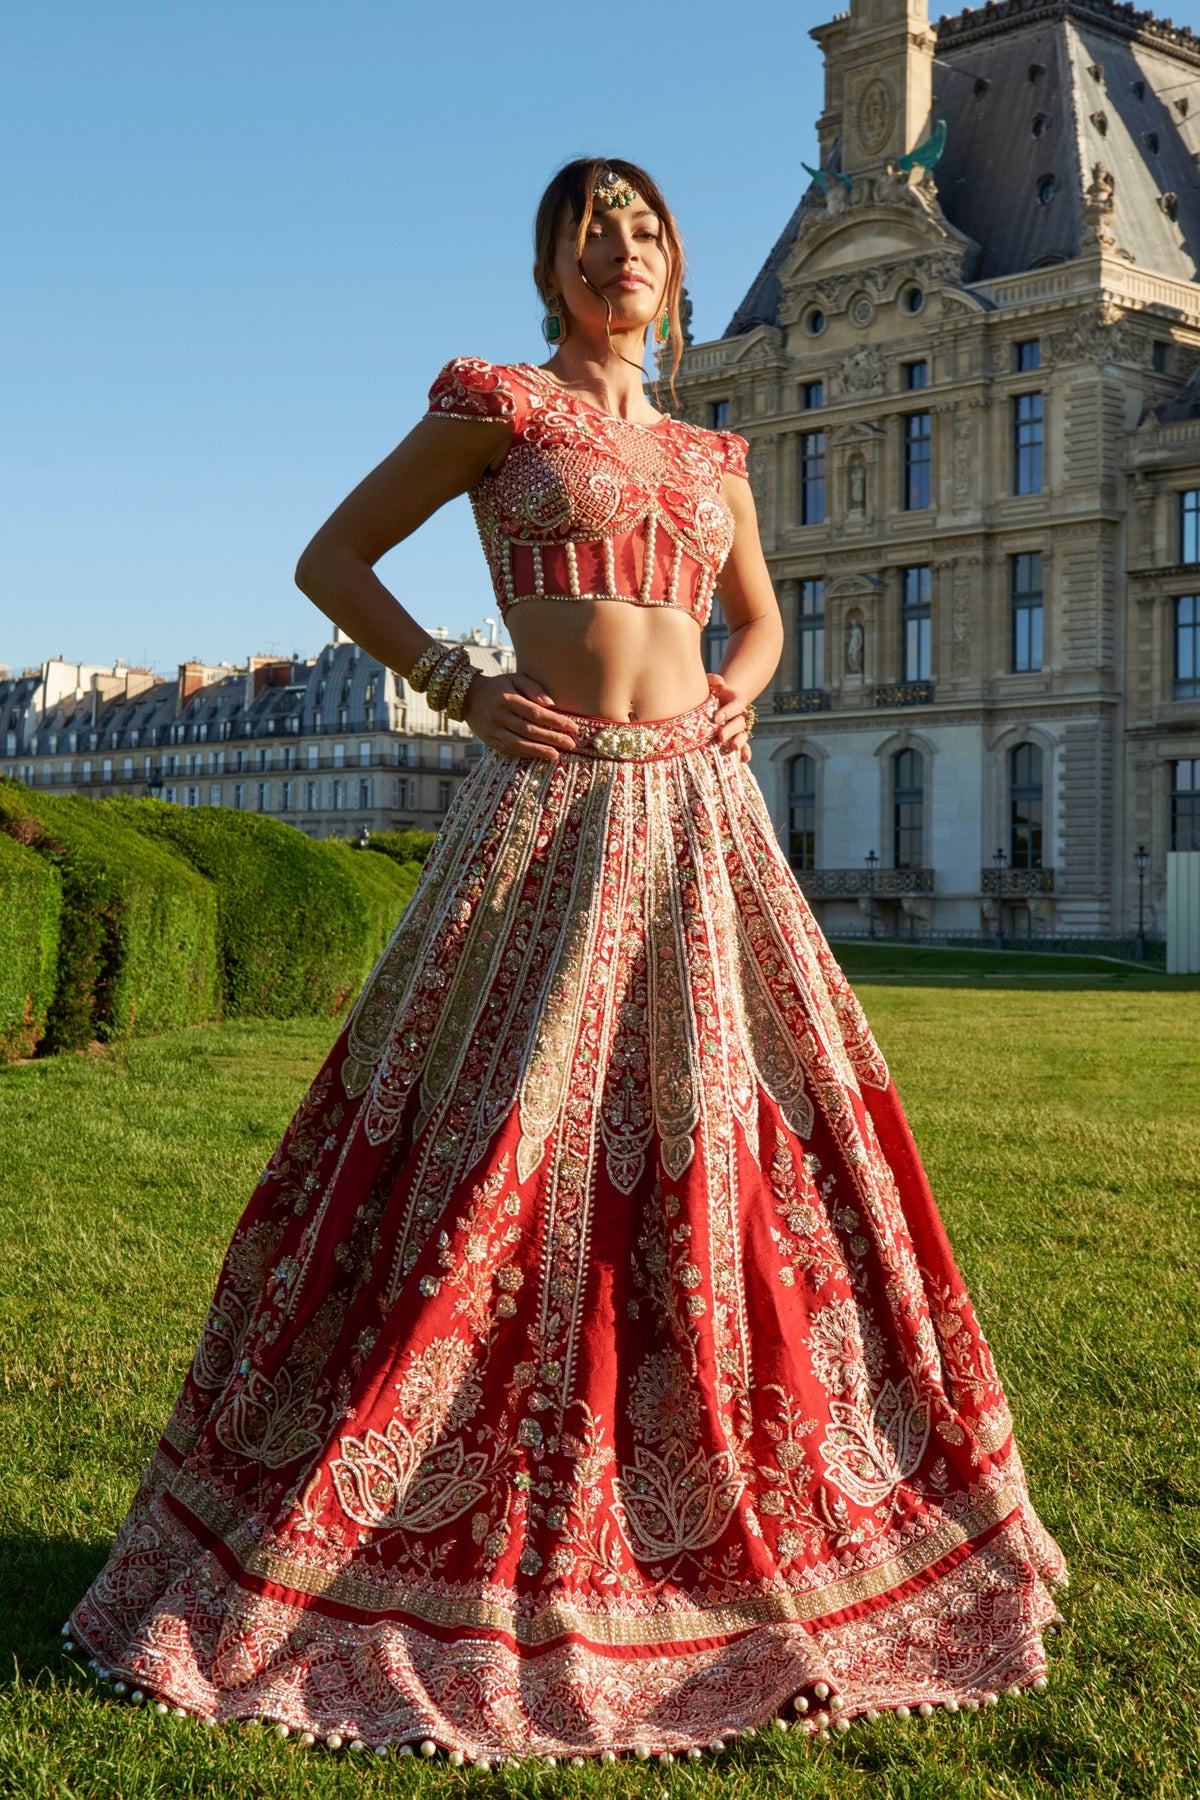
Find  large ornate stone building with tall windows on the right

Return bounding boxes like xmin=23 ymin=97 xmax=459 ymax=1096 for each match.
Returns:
xmin=678 ymin=0 xmax=1200 ymax=938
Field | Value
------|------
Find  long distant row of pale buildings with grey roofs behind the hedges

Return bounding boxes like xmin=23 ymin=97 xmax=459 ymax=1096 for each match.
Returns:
xmin=0 ymin=630 xmax=515 ymax=837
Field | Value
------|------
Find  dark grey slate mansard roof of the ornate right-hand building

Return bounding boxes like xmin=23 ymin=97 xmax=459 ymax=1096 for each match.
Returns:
xmin=725 ymin=0 xmax=1200 ymax=337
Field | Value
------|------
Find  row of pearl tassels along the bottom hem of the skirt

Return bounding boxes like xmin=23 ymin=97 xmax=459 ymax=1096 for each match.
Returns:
xmin=63 ymin=1624 xmax=1049 ymax=1769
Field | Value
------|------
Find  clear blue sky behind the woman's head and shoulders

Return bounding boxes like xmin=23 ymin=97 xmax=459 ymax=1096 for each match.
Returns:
xmin=0 ymin=0 xmax=941 ymax=670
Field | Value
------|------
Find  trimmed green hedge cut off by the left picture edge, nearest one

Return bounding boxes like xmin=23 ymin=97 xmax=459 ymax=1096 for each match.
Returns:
xmin=0 ymin=832 xmax=63 ymax=1062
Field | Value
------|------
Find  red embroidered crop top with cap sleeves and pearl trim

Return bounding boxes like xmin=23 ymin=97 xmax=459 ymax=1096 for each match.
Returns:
xmin=430 ymin=356 xmax=747 ymax=625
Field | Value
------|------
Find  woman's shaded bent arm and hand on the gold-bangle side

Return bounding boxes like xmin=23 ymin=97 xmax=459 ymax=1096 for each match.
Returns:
xmin=295 ymin=418 xmax=576 ymax=761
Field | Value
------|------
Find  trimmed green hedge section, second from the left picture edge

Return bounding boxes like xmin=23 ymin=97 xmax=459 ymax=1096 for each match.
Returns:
xmin=0 ymin=779 xmax=219 ymax=1049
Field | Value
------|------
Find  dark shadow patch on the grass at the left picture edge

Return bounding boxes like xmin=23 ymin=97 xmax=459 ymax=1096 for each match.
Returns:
xmin=0 ymin=1534 xmax=112 ymax=1687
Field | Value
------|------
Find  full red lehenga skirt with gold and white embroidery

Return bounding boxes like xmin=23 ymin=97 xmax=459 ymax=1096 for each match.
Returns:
xmin=65 ymin=700 xmax=1065 ymax=1760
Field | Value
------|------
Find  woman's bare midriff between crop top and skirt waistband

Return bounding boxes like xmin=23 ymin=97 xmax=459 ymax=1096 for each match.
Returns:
xmin=506 ymin=599 xmax=709 ymax=720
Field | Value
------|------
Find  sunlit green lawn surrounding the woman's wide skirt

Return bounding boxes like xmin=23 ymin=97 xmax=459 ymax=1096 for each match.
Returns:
xmin=0 ymin=993 xmax=1200 ymax=1800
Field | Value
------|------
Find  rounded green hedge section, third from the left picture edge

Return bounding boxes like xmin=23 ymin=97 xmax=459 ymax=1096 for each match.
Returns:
xmin=104 ymin=799 xmax=371 ymax=1019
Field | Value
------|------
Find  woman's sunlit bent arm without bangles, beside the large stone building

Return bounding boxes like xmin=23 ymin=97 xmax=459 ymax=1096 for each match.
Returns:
xmin=709 ymin=475 xmax=783 ymax=761
